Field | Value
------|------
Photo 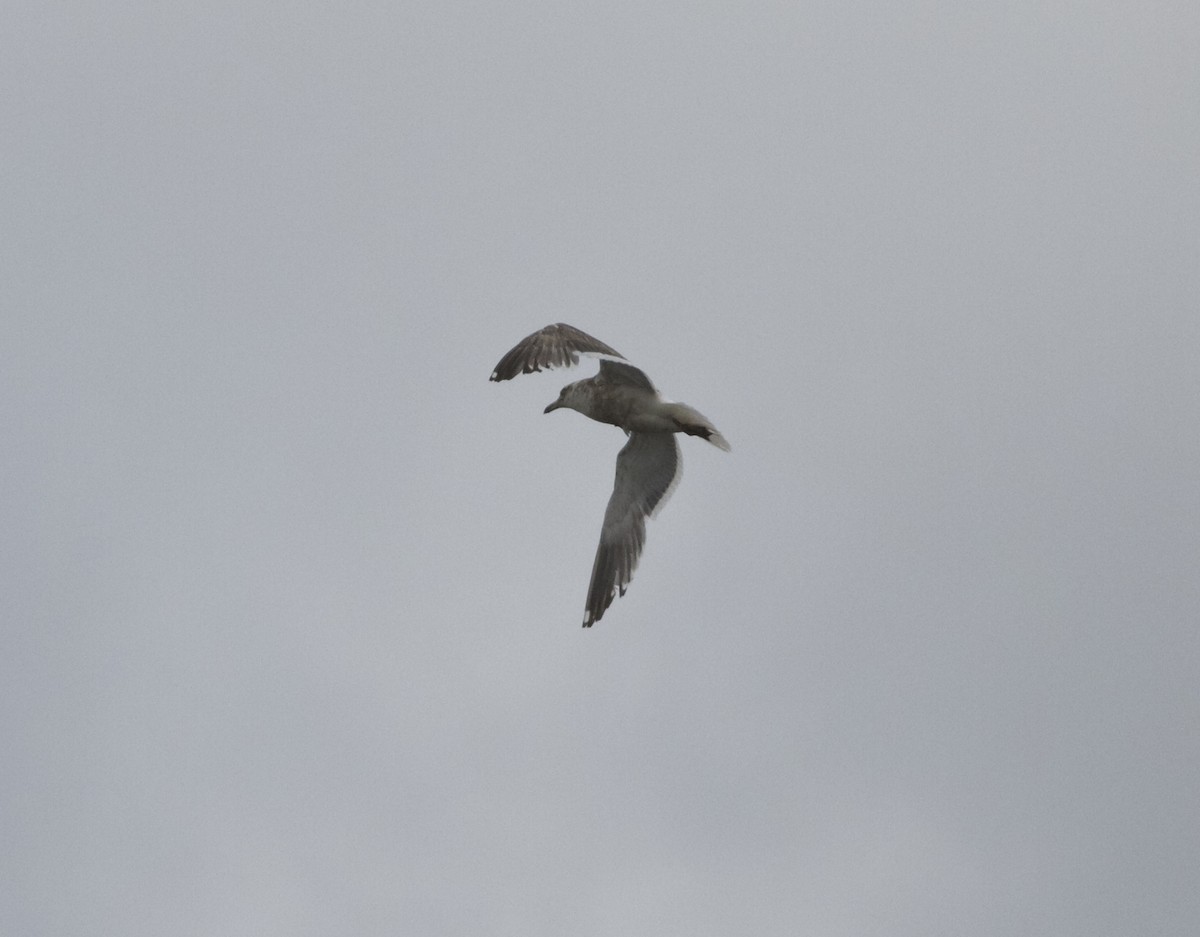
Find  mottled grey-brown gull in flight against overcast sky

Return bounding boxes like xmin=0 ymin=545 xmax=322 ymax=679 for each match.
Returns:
xmin=491 ymin=323 xmax=730 ymax=627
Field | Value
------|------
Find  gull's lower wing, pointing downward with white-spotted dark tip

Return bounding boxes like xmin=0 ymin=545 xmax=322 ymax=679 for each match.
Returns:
xmin=583 ymin=433 xmax=683 ymax=627
